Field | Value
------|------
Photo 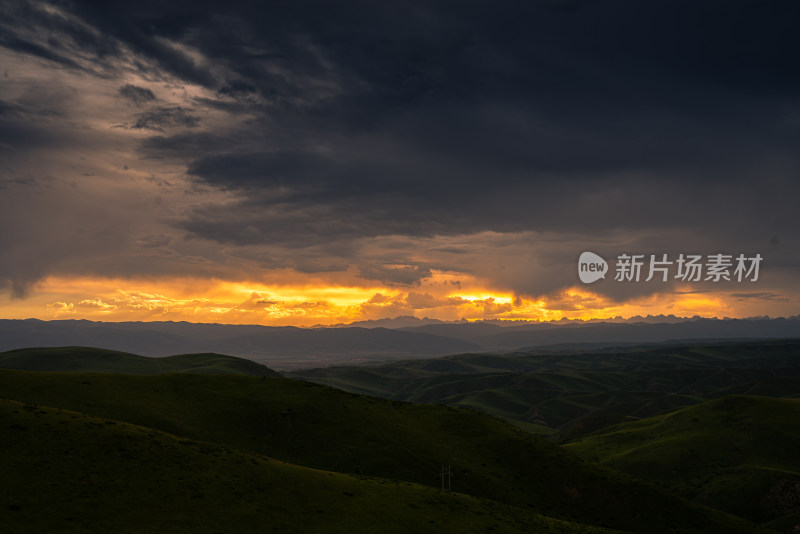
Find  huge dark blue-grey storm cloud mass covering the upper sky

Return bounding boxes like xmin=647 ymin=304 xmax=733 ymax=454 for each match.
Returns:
xmin=0 ymin=0 xmax=800 ymax=302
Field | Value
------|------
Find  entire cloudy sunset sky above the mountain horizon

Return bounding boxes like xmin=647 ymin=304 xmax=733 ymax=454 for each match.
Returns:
xmin=0 ymin=0 xmax=800 ymax=326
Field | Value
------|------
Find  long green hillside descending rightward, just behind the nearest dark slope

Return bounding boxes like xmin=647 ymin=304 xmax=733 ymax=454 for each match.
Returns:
xmin=0 ymin=371 xmax=754 ymax=533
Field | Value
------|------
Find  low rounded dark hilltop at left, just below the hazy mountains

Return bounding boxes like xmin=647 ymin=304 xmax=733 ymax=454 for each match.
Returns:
xmin=0 ymin=347 xmax=280 ymax=376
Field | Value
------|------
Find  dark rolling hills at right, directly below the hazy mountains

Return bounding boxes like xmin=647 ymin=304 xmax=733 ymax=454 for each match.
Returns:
xmin=290 ymin=340 xmax=800 ymax=439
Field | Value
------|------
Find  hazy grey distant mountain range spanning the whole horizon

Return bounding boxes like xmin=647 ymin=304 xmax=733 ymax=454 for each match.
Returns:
xmin=0 ymin=317 xmax=800 ymax=369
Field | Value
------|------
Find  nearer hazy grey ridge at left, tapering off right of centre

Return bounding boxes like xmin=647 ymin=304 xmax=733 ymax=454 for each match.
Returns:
xmin=0 ymin=319 xmax=482 ymax=368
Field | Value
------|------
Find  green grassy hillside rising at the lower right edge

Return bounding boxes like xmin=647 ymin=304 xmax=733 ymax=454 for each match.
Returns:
xmin=566 ymin=396 xmax=800 ymax=528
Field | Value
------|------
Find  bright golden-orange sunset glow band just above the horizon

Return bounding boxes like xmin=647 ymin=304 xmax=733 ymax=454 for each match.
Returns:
xmin=3 ymin=277 xmax=780 ymax=327
